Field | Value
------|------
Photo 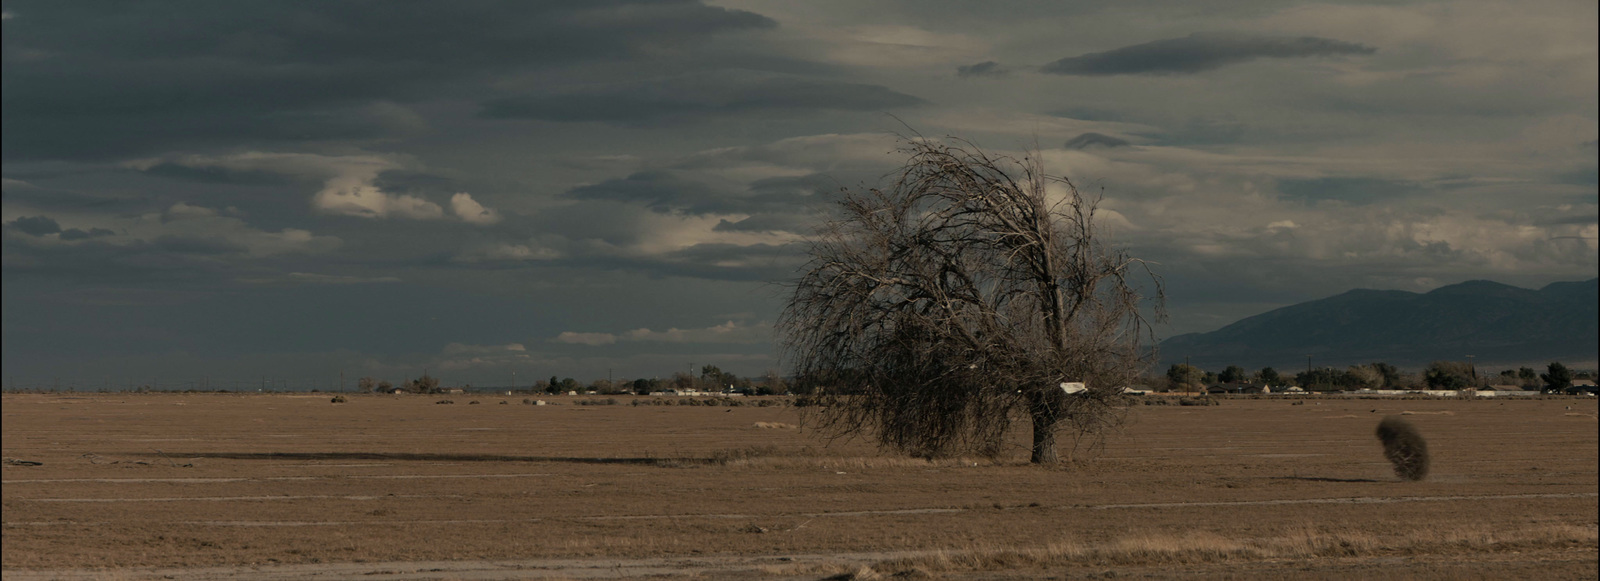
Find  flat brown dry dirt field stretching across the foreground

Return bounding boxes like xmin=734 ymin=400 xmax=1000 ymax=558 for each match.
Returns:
xmin=3 ymin=394 xmax=1600 ymax=579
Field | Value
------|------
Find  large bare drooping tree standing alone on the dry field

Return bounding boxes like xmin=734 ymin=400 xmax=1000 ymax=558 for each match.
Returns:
xmin=779 ymin=139 xmax=1163 ymax=464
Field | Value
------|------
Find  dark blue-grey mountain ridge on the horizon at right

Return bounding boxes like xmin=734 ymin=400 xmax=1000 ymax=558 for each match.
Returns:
xmin=1162 ymin=278 xmax=1600 ymax=370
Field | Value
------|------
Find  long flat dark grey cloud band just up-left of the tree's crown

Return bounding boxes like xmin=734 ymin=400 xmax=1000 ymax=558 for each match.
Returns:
xmin=482 ymin=70 xmax=925 ymax=123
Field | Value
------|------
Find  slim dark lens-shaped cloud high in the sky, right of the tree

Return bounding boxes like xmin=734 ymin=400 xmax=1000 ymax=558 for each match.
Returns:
xmin=1042 ymin=34 xmax=1376 ymax=75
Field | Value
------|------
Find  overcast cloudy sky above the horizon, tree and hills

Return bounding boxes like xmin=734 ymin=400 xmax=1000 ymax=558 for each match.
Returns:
xmin=0 ymin=0 xmax=1600 ymax=387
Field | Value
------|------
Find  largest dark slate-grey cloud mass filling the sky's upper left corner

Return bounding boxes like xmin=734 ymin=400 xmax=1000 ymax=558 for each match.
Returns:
xmin=0 ymin=2 xmax=774 ymax=158
